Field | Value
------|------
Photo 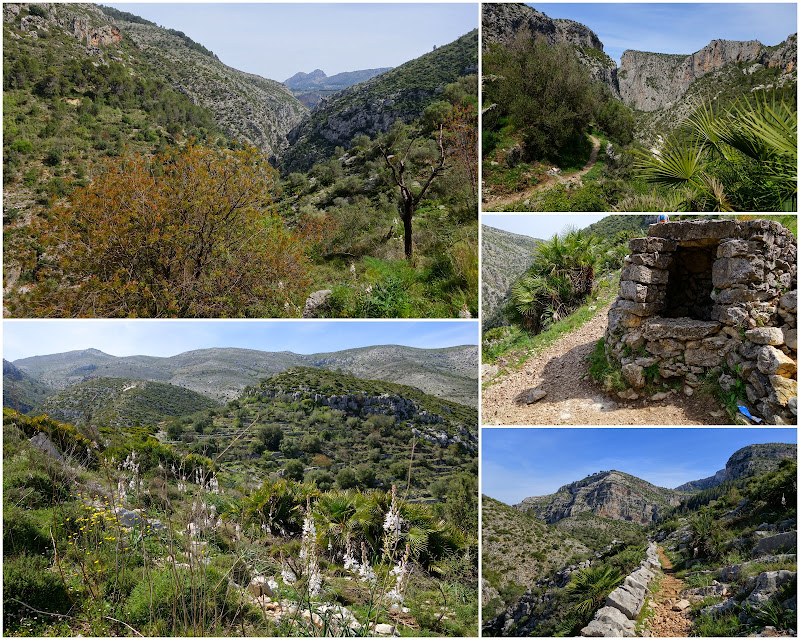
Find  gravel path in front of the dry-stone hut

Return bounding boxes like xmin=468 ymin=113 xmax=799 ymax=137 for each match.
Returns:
xmin=481 ymin=303 xmax=728 ymax=425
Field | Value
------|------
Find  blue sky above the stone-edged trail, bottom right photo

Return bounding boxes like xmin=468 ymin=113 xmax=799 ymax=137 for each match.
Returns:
xmin=481 ymin=427 xmax=797 ymax=504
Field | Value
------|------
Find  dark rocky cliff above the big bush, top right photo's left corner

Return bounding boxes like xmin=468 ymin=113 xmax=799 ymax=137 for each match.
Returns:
xmin=482 ymin=3 xmax=619 ymax=97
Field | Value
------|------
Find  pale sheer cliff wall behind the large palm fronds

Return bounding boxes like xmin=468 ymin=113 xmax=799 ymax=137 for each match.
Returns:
xmin=617 ymin=34 xmax=797 ymax=111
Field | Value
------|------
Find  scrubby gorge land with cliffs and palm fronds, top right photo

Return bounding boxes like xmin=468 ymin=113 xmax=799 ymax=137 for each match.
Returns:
xmin=482 ymin=3 xmax=797 ymax=212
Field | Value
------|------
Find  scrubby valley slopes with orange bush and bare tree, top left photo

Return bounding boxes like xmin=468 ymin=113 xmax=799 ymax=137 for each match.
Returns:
xmin=3 ymin=3 xmax=478 ymax=317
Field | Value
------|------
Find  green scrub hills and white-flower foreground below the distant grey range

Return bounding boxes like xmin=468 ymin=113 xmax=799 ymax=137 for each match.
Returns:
xmin=3 ymin=360 xmax=478 ymax=636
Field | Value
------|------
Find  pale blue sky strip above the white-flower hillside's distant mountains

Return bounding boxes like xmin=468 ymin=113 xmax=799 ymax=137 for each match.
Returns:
xmin=3 ymin=320 xmax=478 ymax=361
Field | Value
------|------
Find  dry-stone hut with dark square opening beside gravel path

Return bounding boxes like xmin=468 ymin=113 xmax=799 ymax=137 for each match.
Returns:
xmin=605 ymin=220 xmax=797 ymax=424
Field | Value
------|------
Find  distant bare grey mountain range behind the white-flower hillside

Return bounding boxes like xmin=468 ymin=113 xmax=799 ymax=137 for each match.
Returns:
xmin=3 ymin=345 xmax=478 ymax=410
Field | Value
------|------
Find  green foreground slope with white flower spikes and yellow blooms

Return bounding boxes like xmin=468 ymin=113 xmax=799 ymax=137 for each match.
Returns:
xmin=3 ymin=404 xmax=478 ymax=636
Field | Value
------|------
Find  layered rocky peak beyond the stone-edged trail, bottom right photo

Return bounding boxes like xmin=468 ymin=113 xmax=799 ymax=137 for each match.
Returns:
xmin=514 ymin=471 xmax=681 ymax=525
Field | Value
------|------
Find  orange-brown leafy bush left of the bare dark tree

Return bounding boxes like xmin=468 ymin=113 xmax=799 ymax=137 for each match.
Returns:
xmin=12 ymin=145 xmax=320 ymax=317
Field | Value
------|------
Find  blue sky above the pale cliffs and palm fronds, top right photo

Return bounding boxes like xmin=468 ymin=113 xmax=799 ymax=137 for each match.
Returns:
xmin=529 ymin=2 xmax=797 ymax=64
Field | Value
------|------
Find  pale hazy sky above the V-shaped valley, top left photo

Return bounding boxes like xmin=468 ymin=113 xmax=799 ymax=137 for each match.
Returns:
xmin=109 ymin=2 xmax=478 ymax=82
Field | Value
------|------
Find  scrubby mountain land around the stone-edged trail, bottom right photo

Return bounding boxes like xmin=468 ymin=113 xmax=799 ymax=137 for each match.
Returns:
xmin=482 ymin=443 xmax=797 ymax=637
